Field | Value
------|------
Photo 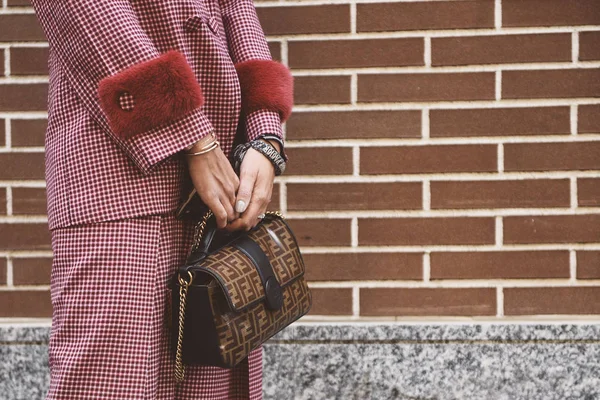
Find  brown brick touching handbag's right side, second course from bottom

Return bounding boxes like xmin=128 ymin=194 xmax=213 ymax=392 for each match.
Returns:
xmin=302 ymin=252 xmax=423 ymax=281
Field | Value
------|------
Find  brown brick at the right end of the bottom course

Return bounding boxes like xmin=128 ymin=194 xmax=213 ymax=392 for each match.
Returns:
xmin=504 ymin=286 xmax=600 ymax=315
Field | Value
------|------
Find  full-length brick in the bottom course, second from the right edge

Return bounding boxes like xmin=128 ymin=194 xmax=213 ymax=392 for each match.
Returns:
xmin=360 ymin=288 xmax=496 ymax=316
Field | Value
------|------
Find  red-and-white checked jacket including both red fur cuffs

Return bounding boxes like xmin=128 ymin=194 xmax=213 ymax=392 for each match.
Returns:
xmin=31 ymin=0 xmax=293 ymax=229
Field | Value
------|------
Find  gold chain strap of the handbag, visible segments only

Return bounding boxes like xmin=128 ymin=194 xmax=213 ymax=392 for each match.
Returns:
xmin=175 ymin=210 xmax=284 ymax=383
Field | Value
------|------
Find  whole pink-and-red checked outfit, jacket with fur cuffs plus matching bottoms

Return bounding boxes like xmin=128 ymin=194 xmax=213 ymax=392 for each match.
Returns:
xmin=31 ymin=0 xmax=293 ymax=400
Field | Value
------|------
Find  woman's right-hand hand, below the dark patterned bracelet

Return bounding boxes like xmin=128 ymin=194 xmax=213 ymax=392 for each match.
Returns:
xmin=225 ymin=142 xmax=279 ymax=232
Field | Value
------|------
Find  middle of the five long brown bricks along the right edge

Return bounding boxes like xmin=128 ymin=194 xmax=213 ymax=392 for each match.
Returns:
xmin=504 ymin=141 xmax=600 ymax=171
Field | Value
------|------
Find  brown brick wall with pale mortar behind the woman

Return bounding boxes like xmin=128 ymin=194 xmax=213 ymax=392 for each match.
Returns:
xmin=0 ymin=0 xmax=600 ymax=320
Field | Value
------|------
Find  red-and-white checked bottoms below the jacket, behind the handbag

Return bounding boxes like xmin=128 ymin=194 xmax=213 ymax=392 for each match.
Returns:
xmin=47 ymin=214 xmax=262 ymax=400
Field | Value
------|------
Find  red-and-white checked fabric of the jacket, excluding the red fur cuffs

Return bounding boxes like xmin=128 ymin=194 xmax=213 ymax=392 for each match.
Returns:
xmin=31 ymin=0 xmax=283 ymax=229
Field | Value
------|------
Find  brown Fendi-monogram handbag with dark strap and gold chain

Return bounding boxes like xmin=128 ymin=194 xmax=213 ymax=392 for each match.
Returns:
xmin=170 ymin=206 xmax=312 ymax=382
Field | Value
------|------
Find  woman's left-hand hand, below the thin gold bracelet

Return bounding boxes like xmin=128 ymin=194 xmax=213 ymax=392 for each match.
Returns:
xmin=185 ymin=142 xmax=239 ymax=228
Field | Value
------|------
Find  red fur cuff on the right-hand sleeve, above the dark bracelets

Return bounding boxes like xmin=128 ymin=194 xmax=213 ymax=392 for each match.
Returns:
xmin=235 ymin=59 xmax=294 ymax=122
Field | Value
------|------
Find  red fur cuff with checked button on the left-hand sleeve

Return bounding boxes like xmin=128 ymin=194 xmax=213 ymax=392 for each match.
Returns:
xmin=98 ymin=50 xmax=204 ymax=139
